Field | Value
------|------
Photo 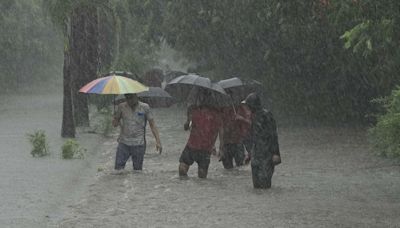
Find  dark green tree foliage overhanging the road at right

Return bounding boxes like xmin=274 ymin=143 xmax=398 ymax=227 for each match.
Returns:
xmin=154 ymin=0 xmax=400 ymax=122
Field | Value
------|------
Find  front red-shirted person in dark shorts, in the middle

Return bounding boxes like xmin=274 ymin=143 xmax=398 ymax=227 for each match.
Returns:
xmin=179 ymin=96 xmax=223 ymax=178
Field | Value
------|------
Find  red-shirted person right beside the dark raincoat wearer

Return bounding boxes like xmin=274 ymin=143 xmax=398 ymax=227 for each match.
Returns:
xmin=220 ymin=105 xmax=251 ymax=169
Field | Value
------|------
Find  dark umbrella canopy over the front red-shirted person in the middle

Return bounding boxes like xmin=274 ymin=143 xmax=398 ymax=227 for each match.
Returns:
xmin=165 ymin=74 xmax=229 ymax=106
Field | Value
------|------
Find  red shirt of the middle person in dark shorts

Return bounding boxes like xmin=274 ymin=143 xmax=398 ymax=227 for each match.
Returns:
xmin=187 ymin=107 xmax=222 ymax=152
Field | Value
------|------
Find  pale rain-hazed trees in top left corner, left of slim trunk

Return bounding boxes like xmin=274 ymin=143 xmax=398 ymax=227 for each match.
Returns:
xmin=0 ymin=0 xmax=62 ymax=93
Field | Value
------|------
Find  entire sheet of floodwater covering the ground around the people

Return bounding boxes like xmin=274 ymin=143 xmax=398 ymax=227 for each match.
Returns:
xmin=0 ymin=93 xmax=400 ymax=227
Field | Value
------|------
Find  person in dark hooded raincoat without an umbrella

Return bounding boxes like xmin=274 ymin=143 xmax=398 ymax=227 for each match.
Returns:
xmin=243 ymin=93 xmax=281 ymax=188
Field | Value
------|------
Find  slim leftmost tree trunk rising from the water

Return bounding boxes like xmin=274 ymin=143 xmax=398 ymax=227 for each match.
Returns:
xmin=61 ymin=21 xmax=75 ymax=138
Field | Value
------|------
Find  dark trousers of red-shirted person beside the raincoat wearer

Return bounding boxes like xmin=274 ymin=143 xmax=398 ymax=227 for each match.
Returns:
xmin=221 ymin=143 xmax=244 ymax=169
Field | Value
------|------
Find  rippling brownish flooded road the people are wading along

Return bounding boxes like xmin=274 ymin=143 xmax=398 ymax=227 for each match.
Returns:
xmin=59 ymin=109 xmax=400 ymax=227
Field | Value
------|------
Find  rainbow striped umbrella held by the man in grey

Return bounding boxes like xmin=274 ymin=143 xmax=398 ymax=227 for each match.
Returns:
xmin=79 ymin=75 xmax=149 ymax=94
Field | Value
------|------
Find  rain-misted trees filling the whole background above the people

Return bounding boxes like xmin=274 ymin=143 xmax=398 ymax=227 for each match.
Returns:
xmin=0 ymin=0 xmax=400 ymax=123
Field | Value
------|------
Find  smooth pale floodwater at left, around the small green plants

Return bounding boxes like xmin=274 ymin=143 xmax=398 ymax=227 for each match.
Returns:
xmin=0 ymin=94 xmax=101 ymax=227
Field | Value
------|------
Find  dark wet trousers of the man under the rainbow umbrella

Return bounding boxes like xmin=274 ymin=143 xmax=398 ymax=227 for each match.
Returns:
xmin=115 ymin=143 xmax=145 ymax=170
